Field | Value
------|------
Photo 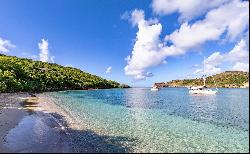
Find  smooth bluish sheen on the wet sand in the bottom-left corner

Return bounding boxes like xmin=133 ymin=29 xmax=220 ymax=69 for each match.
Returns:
xmin=4 ymin=114 xmax=68 ymax=153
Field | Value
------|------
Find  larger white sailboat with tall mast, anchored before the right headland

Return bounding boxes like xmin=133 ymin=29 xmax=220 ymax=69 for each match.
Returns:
xmin=189 ymin=57 xmax=218 ymax=94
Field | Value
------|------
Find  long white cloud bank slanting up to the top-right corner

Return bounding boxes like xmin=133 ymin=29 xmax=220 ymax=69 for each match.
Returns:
xmin=165 ymin=0 xmax=249 ymax=50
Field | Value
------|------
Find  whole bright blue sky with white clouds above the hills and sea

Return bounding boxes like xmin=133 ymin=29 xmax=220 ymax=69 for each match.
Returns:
xmin=0 ymin=0 xmax=249 ymax=87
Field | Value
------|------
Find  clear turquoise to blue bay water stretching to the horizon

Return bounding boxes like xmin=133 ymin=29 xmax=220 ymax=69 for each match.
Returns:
xmin=49 ymin=88 xmax=249 ymax=152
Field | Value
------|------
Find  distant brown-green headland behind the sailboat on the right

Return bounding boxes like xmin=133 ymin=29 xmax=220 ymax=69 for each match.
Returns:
xmin=155 ymin=71 xmax=249 ymax=88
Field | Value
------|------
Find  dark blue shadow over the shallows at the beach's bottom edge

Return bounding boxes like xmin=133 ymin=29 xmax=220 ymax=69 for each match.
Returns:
xmin=50 ymin=113 xmax=137 ymax=153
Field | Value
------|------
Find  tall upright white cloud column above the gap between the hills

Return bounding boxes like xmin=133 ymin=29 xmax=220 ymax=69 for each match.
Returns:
xmin=124 ymin=10 xmax=177 ymax=80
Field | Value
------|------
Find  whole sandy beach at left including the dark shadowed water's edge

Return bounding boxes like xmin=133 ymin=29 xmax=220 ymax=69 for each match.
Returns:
xmin=0 ymin=93 xmax=137 ymax=153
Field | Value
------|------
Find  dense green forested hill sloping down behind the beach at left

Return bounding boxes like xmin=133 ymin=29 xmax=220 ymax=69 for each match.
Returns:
xmin=0 ymin=54 xmax=129 ymax=92
